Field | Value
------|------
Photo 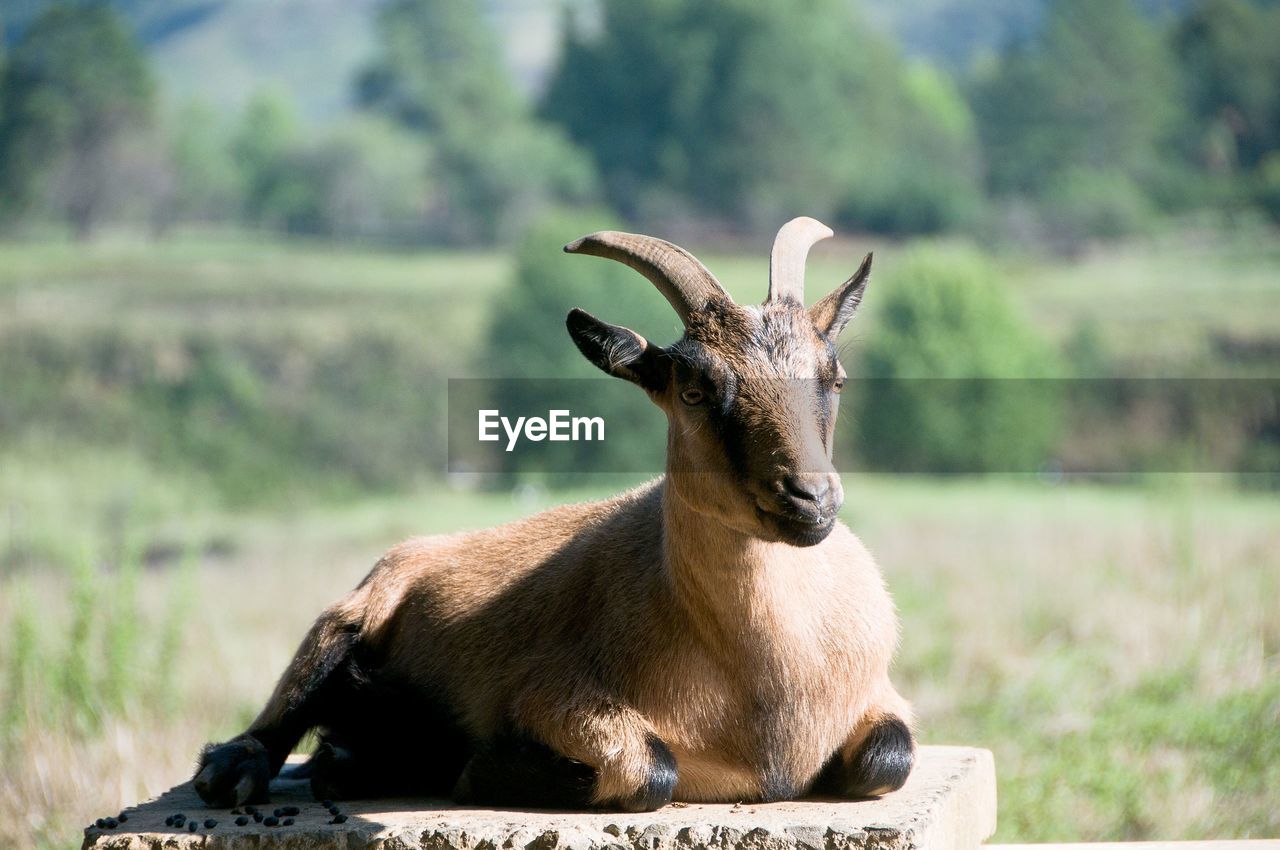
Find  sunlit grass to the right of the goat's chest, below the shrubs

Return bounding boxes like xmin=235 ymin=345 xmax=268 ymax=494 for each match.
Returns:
xmin=846 ymin=476 xmax=1280 ymax=841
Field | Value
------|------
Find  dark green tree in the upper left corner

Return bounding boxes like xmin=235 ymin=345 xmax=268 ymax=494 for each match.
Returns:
xmin=0 ymin=3 xmax=155 ymax=237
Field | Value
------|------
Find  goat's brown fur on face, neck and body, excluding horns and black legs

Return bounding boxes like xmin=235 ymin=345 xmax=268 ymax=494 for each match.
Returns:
xmin=197 ymin=218 xmax=910 ymax=808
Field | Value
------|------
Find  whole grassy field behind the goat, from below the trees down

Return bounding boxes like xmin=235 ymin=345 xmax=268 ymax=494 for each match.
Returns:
xmin=0 ymin=237 xmax=1280 ymax=849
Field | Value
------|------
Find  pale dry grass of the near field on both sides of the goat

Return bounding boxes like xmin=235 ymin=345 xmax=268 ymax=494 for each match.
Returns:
xmin=0 ymin=468 xmax=1280 ymax=850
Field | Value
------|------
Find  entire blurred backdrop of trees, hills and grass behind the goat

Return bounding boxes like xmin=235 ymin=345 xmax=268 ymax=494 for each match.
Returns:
xmin=0 ymin=0 xmax=1280 ymax=850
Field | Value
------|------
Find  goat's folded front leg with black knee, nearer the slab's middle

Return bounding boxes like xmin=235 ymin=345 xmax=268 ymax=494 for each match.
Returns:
xmin=454 ymin=687 xmax=676 ymax=812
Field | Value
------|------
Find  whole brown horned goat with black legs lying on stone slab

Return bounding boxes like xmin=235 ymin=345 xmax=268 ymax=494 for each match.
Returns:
xmin=195 ymin=218 xmax=915 ymax=812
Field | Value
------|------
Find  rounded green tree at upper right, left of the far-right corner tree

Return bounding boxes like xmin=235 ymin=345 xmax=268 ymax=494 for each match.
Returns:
xmin=973 ymin=0 xmax=1178 ymax=196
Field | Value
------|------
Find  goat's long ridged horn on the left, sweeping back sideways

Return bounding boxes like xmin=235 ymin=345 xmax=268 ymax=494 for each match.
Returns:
xmin=564 ymin=230 xmax=731 ymax=326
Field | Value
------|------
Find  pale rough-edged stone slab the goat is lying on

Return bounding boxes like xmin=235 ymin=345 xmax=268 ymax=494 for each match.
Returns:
xmin=83 ymin=746 xmax=996 ymax=850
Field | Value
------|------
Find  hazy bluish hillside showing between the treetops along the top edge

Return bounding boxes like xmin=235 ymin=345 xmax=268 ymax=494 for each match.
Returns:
xmin=0 ymin=0 xmax=1194 ymax=123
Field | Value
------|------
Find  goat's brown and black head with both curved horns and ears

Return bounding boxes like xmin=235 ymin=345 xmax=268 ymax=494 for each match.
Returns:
xmin=564 ymin=218 xmax=872 ymax=545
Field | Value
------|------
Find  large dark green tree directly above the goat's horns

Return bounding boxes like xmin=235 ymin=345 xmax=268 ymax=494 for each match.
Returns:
xmin=543 ymin=0 xmax=974 ymax=230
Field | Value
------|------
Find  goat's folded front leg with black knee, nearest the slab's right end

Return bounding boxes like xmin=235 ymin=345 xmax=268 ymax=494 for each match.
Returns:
xmin=813 ymin=693 xmax=915 ymax=800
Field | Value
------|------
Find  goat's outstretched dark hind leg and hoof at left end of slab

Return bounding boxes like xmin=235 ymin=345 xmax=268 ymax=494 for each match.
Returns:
xmin=186 ymin=607 xmax=357 ymax=808
